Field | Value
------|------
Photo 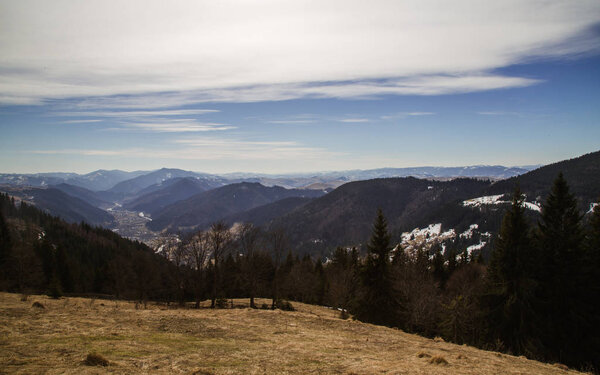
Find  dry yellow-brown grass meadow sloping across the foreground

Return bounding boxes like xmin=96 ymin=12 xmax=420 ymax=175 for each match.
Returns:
xmin=0 ymin=293 xmax=577 ymax=375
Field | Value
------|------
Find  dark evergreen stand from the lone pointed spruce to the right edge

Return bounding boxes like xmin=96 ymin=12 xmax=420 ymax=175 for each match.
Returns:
xmin=351 ymin=174 xmax=600 ymax=371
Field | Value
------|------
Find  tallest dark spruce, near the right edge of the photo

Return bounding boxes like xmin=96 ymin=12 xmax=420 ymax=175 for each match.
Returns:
xmin=537 ymin=173 xmax=584 ymax=364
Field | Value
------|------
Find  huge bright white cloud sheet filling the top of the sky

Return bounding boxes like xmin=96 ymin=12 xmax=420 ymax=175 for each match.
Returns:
xmin=0 ymin=0 xmax=600 ymax=104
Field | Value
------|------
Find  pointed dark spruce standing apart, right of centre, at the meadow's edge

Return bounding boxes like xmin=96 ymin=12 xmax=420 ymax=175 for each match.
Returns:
xmin=356 ymin=209 xmax=398 ymax=326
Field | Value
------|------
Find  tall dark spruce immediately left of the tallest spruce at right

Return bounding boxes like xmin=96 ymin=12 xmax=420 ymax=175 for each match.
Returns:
xmin=484 ymin=186 xmax=540 ymax=356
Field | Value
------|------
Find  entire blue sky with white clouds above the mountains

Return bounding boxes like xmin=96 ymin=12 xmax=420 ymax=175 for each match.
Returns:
xmin=0 ymin=0 xmax=600 ymax=173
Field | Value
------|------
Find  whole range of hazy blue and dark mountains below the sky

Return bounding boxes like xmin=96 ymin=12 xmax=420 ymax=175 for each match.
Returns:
xmin=0 ymin=152 xmax=600 ymax=255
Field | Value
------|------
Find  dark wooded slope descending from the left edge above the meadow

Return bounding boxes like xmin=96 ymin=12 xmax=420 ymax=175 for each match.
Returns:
xmin=0 ymin=194 xmax=177 ymax=299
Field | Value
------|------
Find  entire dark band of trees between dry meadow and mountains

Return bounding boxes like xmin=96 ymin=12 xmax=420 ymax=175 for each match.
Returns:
xmin=0 ymin=174 xmax=600 ymax=370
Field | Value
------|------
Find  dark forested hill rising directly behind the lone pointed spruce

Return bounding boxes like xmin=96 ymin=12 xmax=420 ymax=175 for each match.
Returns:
xmin=272 ymin=177 xmax=489 ymax=253
